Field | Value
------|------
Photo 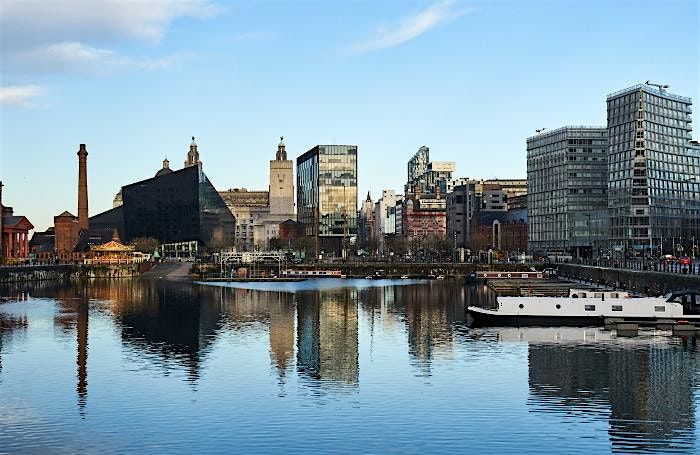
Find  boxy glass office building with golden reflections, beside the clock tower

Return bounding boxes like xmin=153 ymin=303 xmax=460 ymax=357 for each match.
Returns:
xmin=297 ymin=145 xmax=357 ymax=255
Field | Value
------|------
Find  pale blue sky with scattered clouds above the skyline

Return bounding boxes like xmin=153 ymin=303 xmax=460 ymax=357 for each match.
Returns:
xmin=0 ymin=0 xmax=700 ymax=230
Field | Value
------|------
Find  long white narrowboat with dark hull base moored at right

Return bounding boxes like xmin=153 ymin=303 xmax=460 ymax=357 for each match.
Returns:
xmin=467 ymin=289 xmax=700 ymax=327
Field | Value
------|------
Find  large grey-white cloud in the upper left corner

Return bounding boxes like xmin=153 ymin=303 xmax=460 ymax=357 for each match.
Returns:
xmin=0 ymin=0 xmax=222 ymax=75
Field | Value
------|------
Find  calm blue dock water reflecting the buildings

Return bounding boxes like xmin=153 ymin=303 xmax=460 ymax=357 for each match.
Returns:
xmin=0 ymin=280 xmax=700 ymax=453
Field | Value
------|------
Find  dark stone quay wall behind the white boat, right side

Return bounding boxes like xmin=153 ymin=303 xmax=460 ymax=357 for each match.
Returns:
xmin=557 ymin=264 xmax=700 ymax=295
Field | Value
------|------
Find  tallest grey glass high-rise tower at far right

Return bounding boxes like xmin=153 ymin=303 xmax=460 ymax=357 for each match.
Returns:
xmin=607 ymin=84 xmax=700 ymax=257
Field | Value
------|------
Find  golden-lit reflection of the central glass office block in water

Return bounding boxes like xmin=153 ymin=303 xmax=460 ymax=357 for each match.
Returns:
xmin=296 ymin=288 xmax=360 ymax=386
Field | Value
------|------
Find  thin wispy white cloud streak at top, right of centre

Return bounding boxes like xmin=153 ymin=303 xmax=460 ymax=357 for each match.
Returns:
xmin=351 ymin=0 xmax=468 ymax=53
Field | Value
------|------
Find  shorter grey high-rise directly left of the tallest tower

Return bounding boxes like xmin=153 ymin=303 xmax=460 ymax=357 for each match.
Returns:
xmin=527 ymin=126 xmax=608 ymax=257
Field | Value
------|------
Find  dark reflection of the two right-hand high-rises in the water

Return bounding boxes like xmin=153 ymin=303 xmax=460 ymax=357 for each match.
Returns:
xmin=528 ymin=340 xmax=698 ymax=452
